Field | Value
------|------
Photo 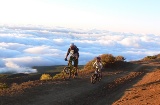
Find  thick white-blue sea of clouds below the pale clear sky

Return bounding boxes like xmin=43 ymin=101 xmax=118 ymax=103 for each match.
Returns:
xmin=0 ymin=26 xmax=160 ymax=73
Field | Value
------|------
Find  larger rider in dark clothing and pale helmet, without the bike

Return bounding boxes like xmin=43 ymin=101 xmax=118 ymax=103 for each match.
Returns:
xmin=65 ymin=43 xmax=79 ymax=76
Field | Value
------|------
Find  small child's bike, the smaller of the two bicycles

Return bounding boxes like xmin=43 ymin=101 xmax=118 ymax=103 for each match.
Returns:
xmin=90 ymin=69 xmax=102 ymax=84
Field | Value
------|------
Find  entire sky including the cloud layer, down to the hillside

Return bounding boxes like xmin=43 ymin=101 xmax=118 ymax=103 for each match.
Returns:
xmin=0 ymin=0 xmax=160 ymax=73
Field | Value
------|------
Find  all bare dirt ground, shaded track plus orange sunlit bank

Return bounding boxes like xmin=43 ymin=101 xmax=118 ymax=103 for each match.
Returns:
xmin=0 ymin=62 xmax=160 ymax=105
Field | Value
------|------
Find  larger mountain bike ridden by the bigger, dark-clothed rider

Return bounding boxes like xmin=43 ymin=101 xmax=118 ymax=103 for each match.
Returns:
xmin=62 ymin=57 xmax=77 ymax=79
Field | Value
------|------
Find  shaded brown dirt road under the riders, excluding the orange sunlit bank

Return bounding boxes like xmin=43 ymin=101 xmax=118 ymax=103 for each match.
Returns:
xmin=0 ymin=60 xmax=160 ymax=105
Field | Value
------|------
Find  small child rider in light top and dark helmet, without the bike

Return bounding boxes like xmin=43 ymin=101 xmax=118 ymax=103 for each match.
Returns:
xmin=93 ymin=57 xmax=103 ymax=77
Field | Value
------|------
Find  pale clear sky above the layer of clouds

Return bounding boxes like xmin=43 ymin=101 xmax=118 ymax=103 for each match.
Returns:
xmin=0 ymin=0 xmax=160 ymax=34
